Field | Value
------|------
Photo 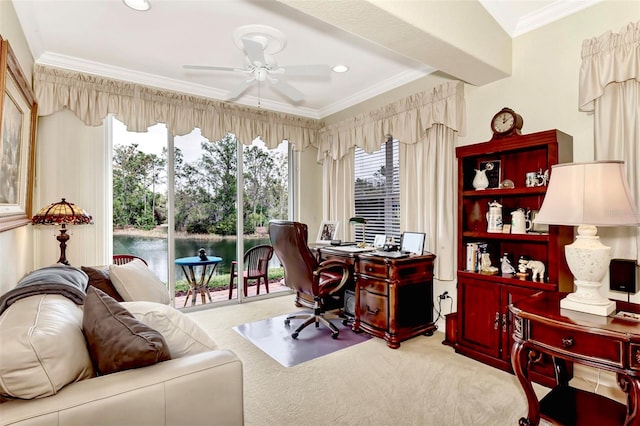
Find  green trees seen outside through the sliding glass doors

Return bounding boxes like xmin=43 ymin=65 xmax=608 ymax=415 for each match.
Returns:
xmin=113 ymin=134 xmax=289 ymax=235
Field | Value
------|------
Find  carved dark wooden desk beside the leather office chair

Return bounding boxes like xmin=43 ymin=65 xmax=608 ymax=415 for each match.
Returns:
xmin=320 ymin=247 xmax=437 ymax=349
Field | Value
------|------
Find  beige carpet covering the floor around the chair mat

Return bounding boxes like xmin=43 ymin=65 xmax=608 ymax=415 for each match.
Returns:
xmin=189 ymin=296 xmax=548 ymax=426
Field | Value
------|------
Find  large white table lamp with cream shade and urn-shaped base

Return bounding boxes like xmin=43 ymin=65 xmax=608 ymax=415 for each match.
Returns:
xmin=534 ymin=161 xmax=640 ymax=316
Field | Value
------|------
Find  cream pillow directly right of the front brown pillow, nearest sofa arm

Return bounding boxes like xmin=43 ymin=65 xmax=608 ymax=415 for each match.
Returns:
xmin=121 ymin=302 xmax=217 ymax=358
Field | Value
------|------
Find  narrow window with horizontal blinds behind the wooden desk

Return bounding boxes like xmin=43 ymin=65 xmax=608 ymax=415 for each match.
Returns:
xmin=355 ymin=138 xmax=400 ymax=243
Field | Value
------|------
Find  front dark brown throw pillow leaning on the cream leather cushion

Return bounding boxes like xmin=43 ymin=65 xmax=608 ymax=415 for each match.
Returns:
xmin=82 ymin=287 xmax=171 ymax=375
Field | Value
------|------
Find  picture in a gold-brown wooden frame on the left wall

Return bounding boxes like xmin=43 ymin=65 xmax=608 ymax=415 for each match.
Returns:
xmin=0 ymin=37 xmax=37 ymax=232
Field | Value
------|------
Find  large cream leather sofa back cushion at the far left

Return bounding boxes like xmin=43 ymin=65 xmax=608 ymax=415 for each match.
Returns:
xmin=0 ymin=294 xmax=94 ymax=399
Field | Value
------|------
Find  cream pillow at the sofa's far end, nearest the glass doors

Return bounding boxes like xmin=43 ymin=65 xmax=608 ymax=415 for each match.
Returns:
xmin=109 ymin=259 xmax=171 ymax=305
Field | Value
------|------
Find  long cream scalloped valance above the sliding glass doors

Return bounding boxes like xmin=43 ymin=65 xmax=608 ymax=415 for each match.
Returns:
xmin=34 ymin=64 xmax=319 ymax=151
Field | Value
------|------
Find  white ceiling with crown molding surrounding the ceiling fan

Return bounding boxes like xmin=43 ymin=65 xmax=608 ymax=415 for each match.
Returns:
xmin=12 ymin=0 xmax=600 ymax=118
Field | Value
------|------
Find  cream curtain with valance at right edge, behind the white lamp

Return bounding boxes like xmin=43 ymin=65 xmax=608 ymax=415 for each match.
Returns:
xmin=579 ymin=21 xmax=640 ymax=264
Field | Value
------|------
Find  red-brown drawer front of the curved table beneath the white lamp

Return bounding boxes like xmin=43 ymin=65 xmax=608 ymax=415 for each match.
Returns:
xmin=530 ymin=322 xmax=624 ymax=367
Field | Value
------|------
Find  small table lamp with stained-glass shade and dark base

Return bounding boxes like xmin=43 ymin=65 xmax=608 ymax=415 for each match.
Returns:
xmin=31 ymin=198 xmax=93 ymax=265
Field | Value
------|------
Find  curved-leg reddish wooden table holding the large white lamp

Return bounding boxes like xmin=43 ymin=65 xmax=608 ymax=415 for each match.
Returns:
xmin=509 ymin=292 xmax=640 ymax=426
